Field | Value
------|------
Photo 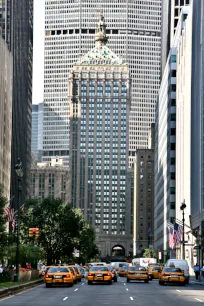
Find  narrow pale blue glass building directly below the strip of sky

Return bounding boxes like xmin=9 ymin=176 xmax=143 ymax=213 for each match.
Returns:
xmin=31 ymin=103 xmax=43 ymax=161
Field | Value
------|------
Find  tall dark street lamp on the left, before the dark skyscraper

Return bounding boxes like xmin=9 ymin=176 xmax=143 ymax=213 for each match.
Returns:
xmin=14 ymin=158 xmax=23 ymax=282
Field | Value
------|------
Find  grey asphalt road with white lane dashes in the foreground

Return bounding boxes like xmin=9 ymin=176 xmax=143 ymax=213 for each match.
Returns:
xmin=0 ymin=278 xmax=204 ymax=306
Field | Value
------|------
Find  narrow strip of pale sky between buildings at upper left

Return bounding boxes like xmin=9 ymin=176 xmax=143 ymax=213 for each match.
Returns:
xmin=32 ymin=0 xmax=45 ymax=104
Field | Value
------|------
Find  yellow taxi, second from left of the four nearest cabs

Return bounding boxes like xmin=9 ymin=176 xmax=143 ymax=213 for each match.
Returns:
xmin=87 ymin=266 xmax=112 ymax=285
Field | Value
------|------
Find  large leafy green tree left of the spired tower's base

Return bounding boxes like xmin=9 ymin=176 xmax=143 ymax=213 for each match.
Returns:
xmin=21 ymin=198 xmax=97 ymax=265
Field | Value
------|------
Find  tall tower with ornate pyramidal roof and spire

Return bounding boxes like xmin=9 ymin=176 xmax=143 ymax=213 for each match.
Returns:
xmin=69 ymin=14 xmax=130 ymax=255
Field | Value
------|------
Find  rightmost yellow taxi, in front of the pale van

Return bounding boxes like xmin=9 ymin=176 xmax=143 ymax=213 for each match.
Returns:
xmin=159 ymin=267 xmax=185 ymax=286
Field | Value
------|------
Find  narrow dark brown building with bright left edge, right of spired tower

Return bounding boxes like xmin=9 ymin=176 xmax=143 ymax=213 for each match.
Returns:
xmin=133 ymin=149 xmax=154 ymax=257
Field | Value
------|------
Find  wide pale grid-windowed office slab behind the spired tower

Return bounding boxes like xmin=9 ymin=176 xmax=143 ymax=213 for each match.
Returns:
xmin=43 ymin=0 xmax=161 ymax=165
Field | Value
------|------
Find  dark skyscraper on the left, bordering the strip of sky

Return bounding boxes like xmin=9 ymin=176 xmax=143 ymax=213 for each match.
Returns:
xmin=0 ymin=0 xmax=33 ymax=205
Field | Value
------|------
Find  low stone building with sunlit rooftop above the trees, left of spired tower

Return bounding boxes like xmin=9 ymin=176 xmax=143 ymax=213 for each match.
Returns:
xmin=30 ymin=158 xmax=70 ymax=204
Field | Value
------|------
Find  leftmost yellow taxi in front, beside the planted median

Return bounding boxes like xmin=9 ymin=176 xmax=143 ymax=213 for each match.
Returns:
xmin=44 ymin=266 xmax=74 ymax=287
